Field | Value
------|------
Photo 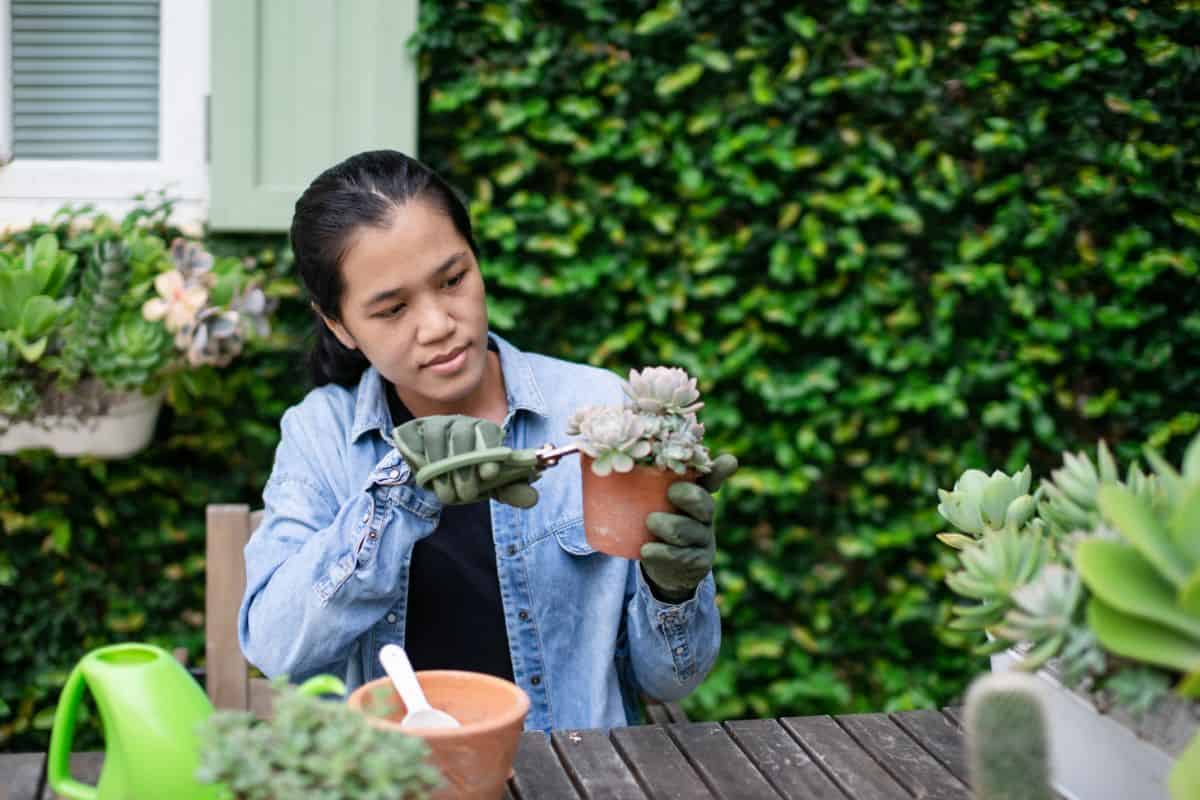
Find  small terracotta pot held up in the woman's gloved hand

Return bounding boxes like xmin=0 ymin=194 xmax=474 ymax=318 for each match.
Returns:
xmin=580 ymin=453 xmax=696 ymax=561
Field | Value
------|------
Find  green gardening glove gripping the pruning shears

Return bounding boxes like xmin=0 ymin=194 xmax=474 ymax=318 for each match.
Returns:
xmin=392 ymin=414 xmax=540 ymax=509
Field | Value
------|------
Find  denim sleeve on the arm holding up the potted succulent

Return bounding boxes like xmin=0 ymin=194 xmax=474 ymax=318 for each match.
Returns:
xmin=625 ymin=561 xmax=721 ymax=702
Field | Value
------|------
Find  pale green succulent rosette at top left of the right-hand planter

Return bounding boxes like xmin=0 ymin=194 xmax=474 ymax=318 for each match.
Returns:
xmin=937 ymin=467 xmax=1037 ymax=547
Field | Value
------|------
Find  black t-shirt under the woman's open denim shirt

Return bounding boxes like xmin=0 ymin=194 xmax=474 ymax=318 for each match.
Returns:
xmin=384 ymin=362 xmax=512 ymax=680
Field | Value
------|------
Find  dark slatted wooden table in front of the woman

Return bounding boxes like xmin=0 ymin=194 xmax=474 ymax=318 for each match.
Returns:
xmin=0 ymin=710 xmax=971 ymax=800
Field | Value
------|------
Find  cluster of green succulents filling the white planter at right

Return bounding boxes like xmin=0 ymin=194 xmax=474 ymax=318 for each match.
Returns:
xmin=938 ymin=435 xmax=1200 ymax=798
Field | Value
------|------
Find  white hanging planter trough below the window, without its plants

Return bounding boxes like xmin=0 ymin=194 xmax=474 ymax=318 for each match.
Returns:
xmin=0 ymin=392 xmax=162 ymax=458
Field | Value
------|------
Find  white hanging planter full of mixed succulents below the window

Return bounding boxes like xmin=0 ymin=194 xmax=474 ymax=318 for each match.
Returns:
xmin=0 ymin=203 xmax=270 ymax=458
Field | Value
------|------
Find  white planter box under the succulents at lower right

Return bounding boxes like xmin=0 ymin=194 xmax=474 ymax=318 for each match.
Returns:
xmin=991 ymin=650 xmax=1198 ymax=800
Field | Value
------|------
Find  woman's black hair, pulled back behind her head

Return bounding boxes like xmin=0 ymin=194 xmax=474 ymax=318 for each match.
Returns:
xmin=290 ymin=150 xmax=479 ymax=387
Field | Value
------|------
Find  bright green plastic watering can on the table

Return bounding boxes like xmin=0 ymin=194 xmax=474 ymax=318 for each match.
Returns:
xmin=47 ymin=643 xmax=346 ymax=800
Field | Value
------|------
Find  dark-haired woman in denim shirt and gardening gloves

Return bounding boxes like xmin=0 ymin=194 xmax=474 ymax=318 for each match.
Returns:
xmin=239 ymin=151 xmax=737 ymax=729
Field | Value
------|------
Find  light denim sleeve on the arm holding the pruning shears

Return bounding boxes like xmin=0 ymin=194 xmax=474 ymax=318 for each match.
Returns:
xmin=238 ymin=410 xmax=442 ymax=680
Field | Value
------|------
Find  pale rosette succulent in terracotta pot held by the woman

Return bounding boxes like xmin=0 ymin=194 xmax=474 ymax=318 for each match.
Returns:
xmin=566 ymin=367 xmax=713 ymax=560
